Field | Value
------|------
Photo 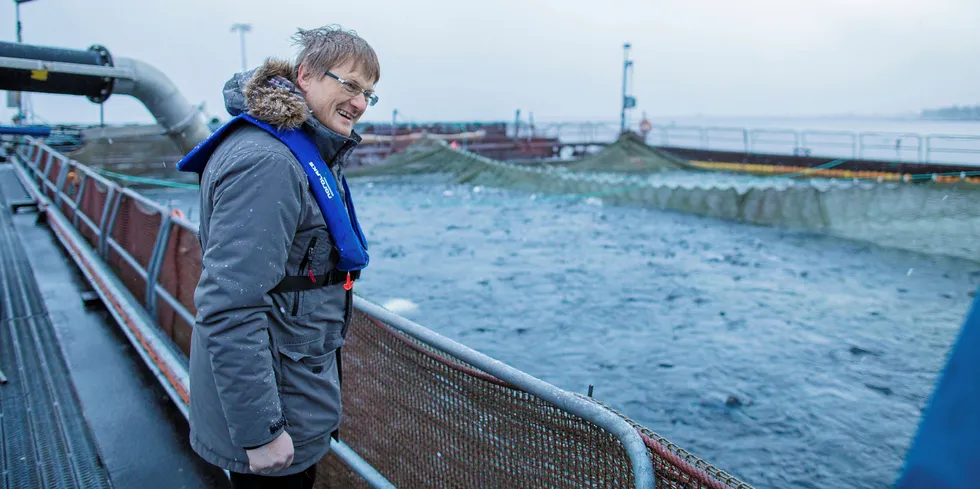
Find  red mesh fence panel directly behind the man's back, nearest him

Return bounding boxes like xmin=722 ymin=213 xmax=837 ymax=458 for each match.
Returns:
xmin=156 ymin=223 xmax=201 ymax=355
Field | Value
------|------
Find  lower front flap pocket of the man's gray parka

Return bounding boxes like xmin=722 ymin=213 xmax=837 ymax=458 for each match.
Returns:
xmin=278 ymin=337 xmax=341 ymax=445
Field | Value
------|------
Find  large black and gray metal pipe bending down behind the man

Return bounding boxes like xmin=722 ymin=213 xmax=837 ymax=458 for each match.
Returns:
xmin=0 ymin=42 xmax=211 ymax=153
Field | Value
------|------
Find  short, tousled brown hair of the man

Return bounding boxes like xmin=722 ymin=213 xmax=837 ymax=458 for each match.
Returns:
xmin=293 ymin=25 xmax=381 ymax=83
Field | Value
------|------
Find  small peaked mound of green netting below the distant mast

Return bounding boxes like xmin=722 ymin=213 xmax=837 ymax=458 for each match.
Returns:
xmin=564 ymin=133 xmax=705 ymax=174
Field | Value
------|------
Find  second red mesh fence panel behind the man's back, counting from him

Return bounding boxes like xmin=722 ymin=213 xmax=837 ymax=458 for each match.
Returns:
xmin=106 ymin=194 xmax=163 ymax=306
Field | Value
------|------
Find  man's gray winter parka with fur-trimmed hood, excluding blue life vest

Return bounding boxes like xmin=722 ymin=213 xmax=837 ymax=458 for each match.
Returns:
xmin=190 ymin=61 xmax=360 ymax=475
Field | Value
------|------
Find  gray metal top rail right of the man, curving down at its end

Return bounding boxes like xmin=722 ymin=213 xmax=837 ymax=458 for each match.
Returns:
xmin=354 ymin=295 xmax=656 ymax=489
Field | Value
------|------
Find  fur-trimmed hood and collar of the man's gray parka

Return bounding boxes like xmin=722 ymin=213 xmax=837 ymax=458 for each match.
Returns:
xmin=224 ymin=58 xmax=361 ymax=162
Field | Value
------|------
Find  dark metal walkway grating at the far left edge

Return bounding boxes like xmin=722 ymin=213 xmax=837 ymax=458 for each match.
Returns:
xmin=0 ymin=173 xmax=111 ymax=489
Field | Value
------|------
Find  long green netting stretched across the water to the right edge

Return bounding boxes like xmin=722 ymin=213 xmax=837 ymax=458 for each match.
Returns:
xmin=348 ymin=136 xmax=980 ymax=261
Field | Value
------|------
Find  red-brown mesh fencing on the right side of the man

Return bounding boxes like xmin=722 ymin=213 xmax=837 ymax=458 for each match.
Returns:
xmin=316 ymin=311 xmax=748 ymax=489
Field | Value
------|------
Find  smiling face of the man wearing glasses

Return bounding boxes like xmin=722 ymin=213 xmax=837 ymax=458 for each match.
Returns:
xmin=298 ymin=61 xmax=374 ymax=136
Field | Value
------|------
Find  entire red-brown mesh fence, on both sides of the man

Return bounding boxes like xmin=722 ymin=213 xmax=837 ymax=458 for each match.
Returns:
xmin=19 ymin=140 xmax=751 ymax=489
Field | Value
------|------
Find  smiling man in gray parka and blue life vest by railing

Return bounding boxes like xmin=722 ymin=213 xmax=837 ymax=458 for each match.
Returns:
xmin=178 ymin=27 xmax=380 ymax=489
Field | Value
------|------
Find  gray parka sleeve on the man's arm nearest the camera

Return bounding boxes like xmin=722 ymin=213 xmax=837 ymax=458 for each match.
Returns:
xmin=191 ymin=150 xmax=305 ymax=448
